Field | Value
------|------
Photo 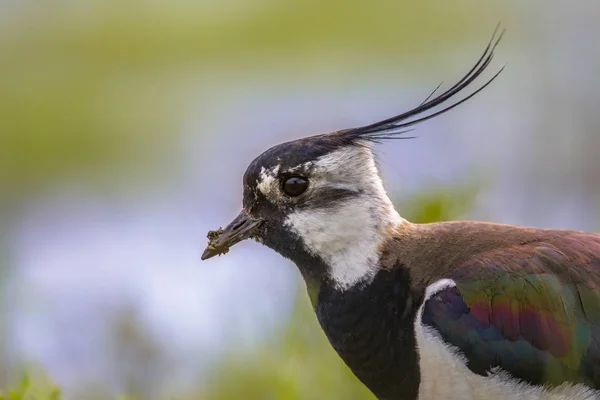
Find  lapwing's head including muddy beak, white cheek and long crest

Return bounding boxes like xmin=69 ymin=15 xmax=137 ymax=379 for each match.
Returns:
xmin=202 ymin=28 xmax=502 ymax=289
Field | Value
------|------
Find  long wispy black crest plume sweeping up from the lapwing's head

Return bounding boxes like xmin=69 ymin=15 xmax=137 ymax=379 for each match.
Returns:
xmin=331 ymin=25 xmax=505 ymax=142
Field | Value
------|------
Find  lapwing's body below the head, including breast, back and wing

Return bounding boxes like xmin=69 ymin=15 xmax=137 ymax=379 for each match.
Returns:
xmin=309 ymin=221 xmax=600 ymax=399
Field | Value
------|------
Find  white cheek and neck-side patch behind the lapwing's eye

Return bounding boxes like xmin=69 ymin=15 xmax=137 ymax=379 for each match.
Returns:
xmin=285 ymin=147 xmax=404 ymax=290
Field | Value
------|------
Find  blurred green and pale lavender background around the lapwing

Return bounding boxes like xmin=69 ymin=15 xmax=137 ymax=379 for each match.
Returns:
xmin=0 ymin=0 xmax=600 ymax=400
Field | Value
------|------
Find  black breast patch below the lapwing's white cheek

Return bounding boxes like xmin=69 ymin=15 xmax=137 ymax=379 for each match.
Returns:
xmin=316 ymin=268 xmax=424 ymax=399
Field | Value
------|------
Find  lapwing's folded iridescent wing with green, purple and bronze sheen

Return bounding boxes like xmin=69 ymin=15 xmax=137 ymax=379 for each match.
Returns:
xmin=422 ymin=233 xmax=600 ymax=389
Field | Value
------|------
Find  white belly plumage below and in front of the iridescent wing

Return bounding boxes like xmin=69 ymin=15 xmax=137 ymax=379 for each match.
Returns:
xmin=415 ymin=279 xmax=600 ymax=400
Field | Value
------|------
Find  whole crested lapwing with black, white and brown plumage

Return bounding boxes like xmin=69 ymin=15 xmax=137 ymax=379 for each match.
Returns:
xmin=201 ymin=30 xmax=600 ymax=400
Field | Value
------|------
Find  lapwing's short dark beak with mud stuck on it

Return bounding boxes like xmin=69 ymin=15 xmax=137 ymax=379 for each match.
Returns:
xmin=201 ymin=211 xmax=262 ymax=260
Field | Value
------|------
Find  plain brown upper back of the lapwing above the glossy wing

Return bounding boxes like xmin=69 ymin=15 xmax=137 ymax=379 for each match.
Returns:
xmin=379 ymin=221 xmax=600 ymax=287
